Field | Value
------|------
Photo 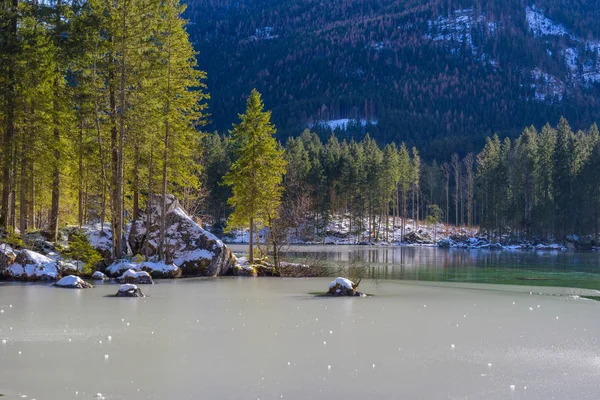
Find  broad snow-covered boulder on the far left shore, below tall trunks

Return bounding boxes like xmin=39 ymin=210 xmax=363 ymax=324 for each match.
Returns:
xmin=4 ymin=250 xmax=59 ymax=281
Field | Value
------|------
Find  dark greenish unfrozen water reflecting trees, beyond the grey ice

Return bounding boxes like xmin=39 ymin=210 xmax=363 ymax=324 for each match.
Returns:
xmin=230 ymin=244 xmax=600 ymax=290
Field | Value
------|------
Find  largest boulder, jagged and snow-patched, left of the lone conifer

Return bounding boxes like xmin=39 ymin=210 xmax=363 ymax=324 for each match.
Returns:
xmin=129 ymin=195 xmax=237 ymax=276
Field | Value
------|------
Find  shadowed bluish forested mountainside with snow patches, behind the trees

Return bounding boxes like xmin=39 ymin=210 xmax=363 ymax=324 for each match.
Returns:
xmin=186 ymin=0 xmax=600 ymax=159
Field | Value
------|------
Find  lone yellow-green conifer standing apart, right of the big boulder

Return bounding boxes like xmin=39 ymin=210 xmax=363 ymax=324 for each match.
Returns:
xmin=224 ymin=89 xmax=286 ymax=262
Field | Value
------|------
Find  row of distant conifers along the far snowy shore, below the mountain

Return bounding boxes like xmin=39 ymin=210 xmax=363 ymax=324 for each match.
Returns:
xmin=203 ymin=119 xmax=600 ymax=240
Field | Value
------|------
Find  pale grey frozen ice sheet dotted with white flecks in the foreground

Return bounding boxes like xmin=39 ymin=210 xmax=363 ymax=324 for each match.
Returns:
xmin=0 ymin=278 xmax=600 ymax=400
